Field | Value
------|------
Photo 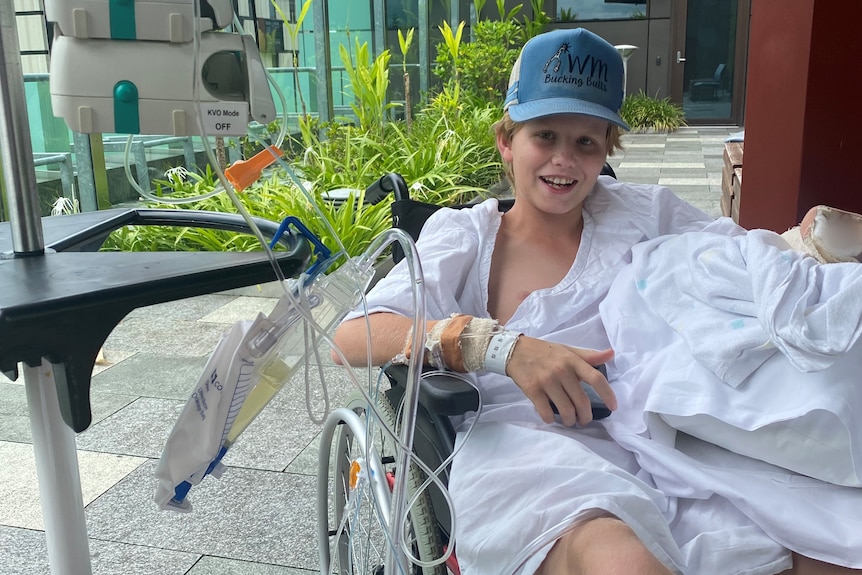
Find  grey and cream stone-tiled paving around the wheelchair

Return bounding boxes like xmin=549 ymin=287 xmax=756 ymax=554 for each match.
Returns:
xmin=0 ymin=127 xmax=738 ymax=575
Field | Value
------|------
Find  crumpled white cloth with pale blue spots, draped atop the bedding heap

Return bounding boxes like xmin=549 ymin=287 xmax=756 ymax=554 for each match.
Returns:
xmin=632 ymin=230 xmax=862 ymax=386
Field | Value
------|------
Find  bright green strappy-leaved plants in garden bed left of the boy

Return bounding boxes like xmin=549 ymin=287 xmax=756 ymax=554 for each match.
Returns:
xmin=105 ymin=46 xmax=502 ymax=264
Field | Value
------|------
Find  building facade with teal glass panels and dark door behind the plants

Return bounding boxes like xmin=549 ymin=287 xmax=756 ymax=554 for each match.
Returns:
xmin=14 ymin=0 xmax=751 ymax=125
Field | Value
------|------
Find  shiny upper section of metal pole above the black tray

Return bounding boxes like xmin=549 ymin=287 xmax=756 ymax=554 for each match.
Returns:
xmin=0 ymin=0 xmax=45 ymax=255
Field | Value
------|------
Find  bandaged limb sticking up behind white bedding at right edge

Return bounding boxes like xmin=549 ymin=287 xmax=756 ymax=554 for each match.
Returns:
xmin=781 ymin=206 xmax=862 ymax=263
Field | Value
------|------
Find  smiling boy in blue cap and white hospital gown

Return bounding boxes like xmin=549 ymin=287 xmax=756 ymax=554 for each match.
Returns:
xmin=335 ymin=29 xmax=860 ymax=575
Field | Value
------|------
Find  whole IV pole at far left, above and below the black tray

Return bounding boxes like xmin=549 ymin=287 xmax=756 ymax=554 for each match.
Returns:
xmin=0 ymin=4 xmax=92 ymax=575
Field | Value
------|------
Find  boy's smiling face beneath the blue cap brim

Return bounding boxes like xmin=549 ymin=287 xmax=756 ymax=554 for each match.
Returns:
xmin=497 ymin=114 xmax=609 ymax=214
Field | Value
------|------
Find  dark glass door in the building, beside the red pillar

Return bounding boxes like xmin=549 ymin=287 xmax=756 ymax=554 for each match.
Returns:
xmin=671 ymin=0 xmax=751 ymax=125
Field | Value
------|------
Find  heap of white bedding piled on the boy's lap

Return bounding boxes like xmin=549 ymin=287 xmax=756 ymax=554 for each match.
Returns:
xmin=601 ymin=231 xmax=862 ymax=567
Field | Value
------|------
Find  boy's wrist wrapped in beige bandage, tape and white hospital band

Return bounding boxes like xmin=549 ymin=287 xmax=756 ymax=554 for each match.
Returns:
xmin=393 ymin=314 xmax=521 ymax=375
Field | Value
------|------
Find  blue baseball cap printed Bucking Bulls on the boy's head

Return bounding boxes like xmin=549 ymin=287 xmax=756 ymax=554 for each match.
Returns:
xmin=503 ymin=28 xmax=630 ymax=130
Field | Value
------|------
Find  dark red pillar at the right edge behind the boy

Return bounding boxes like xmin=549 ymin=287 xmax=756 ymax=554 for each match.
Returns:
xmin=739 ymin=0 xmax=862 ymax=232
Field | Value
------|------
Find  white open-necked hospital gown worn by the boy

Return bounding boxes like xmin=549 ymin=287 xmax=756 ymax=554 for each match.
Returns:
xmin=352 ymin=177 xmax=790 ymax=575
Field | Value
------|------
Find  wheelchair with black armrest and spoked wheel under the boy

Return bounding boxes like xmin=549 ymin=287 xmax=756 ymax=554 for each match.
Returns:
xmin=317 ymin=168 xmax=616 ymax=575
